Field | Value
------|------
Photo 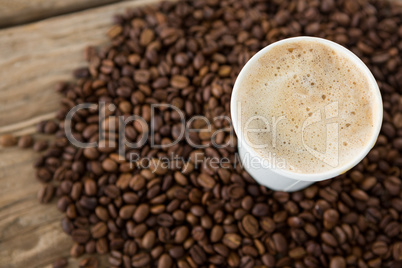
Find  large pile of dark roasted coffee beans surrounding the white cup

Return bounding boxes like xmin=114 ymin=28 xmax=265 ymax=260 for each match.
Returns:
xmin=35 ymin=0 xmax=402 ymax=268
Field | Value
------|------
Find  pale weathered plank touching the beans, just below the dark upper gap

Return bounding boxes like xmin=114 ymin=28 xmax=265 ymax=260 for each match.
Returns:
xmin=0 ymin=0 xmax=158 ymax=127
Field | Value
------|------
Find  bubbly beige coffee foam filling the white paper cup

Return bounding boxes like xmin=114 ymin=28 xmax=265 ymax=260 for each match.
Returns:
xmin=237 ymin=40 xmax=375 ymax=173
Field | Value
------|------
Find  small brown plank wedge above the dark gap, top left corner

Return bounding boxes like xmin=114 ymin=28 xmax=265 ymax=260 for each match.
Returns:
xmin=0 ymin=0 xmax=120 ymax=27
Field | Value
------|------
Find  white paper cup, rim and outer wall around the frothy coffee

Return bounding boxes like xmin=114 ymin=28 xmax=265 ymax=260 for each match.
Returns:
xmin=230 ymin=36 xmax=383 ymax=192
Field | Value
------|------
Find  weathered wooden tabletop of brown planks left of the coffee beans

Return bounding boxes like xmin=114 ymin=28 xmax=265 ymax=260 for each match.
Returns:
xmin=0 ymin=0 xmax=160 ymax=268
